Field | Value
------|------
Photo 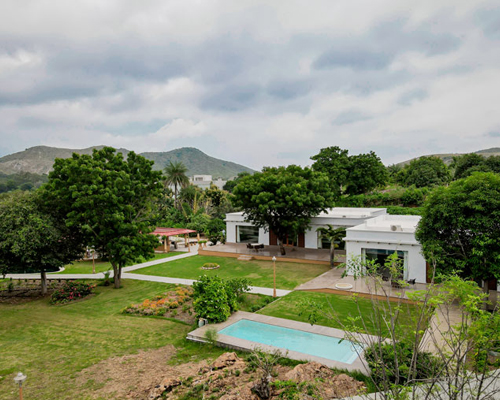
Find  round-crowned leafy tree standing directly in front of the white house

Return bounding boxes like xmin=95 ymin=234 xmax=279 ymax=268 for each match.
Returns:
xmin=234 ymin=165 xmax=334 ymax=255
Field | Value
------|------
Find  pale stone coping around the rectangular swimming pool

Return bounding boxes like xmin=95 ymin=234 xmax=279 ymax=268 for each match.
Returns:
xmin=186 ymin=311 xmax=373 ymax=374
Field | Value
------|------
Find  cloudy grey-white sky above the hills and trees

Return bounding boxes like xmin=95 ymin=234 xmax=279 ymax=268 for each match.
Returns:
xmin=0 ymin=0 xmax=500 ymax=170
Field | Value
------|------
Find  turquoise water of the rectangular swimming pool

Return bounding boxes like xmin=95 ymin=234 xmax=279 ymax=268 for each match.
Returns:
xmin=219 ymin=319 xmax=358 ymax=364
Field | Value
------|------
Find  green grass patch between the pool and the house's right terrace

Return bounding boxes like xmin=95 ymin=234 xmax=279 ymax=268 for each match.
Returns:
xmin=258 ymin=291 xmax=422 ymax=336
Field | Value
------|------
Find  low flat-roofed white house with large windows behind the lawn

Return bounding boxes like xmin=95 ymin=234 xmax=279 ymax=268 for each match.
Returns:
xmin=225 ymin=207 xmax=426 ymax=283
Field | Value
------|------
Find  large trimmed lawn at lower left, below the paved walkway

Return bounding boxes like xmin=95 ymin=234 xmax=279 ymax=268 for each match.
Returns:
xmin=0 ymin=280 xmax=224 ymax=400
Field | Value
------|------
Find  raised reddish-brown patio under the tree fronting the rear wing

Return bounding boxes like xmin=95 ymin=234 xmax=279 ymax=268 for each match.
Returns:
xmin=198 ymin=243 xmax=345 ymax=265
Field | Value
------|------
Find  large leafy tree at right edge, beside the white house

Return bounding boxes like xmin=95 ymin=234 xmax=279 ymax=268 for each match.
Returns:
xmin=416 ymin=172 xmax=500 ymax=281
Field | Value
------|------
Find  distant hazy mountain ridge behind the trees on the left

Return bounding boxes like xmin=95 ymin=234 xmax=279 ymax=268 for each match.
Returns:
xmin=0 ymin=146 xmax=254 ymax=179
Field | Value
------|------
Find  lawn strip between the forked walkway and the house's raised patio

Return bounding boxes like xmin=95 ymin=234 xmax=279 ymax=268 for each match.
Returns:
xmin=132 ymin=256 xmax=330 ymax=289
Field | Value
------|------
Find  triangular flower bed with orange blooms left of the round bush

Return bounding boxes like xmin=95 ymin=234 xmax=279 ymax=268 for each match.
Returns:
xmin=123 ymin=286 xmax=194 ymax=322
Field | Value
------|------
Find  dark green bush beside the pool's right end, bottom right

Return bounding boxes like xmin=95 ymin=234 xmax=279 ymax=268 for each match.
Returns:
xmin=364 ymin=342 xmax=441 ymax=384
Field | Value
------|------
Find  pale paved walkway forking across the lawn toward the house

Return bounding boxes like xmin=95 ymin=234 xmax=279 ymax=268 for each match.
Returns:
xmin=7 ymin=251 xmax=291 ymax=297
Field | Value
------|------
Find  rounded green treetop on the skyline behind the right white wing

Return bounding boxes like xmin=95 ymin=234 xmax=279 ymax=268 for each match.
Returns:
xmin=397 ymin=156 xmax=451 ymax=188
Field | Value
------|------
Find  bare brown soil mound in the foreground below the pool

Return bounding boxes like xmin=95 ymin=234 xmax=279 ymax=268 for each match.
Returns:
xmin=75 ymin=345 xmax=365 ymax=400
